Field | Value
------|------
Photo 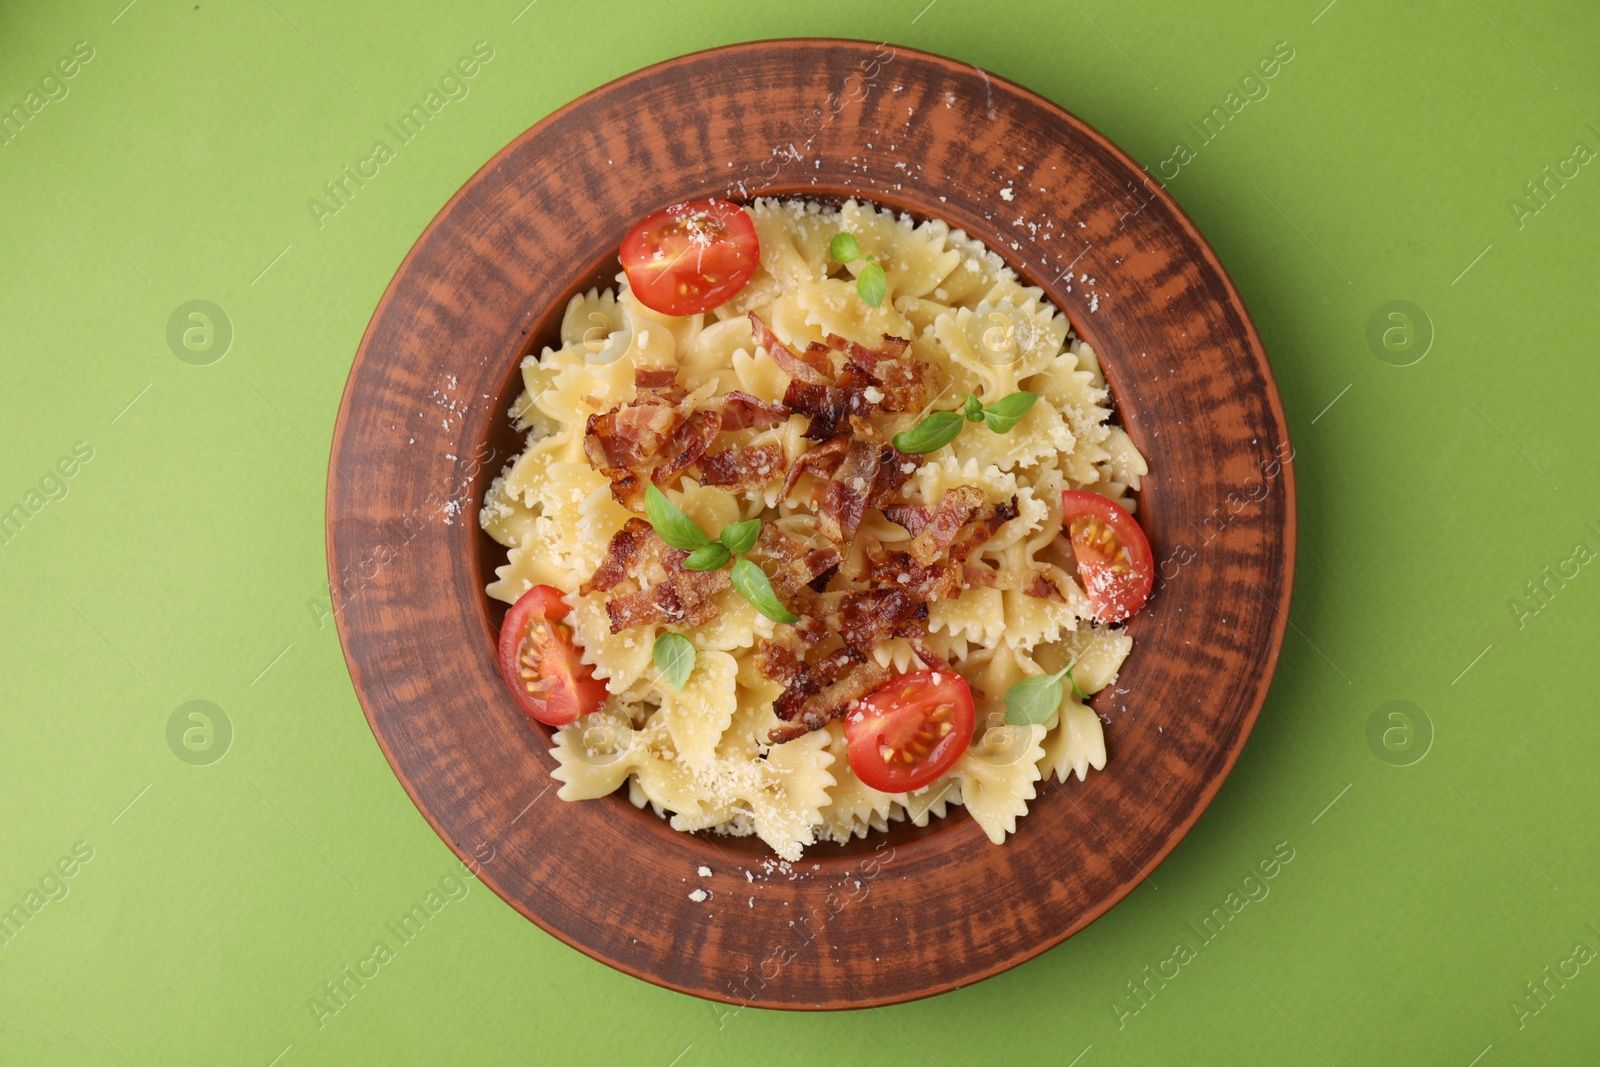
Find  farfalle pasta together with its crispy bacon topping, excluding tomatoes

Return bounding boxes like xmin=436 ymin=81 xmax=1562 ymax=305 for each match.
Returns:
xmin=480 ymin=200 xmax=1147 ymax=861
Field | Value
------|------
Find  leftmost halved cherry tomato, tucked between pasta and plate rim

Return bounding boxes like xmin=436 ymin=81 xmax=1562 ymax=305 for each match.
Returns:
xmin=499 ymin=585 xmax=605 ymax=726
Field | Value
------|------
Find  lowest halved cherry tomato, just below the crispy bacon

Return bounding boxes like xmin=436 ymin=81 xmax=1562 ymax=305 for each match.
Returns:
xmin=845 ymin=670 xmax=973 ymax=793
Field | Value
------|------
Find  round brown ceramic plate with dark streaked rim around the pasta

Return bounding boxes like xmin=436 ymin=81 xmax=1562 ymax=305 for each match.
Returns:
xmin=328 ymin=40 xmax=1294 ymax=1008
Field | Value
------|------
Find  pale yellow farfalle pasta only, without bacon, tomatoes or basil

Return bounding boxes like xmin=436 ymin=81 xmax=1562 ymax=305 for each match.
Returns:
xmin=480 ymin=200 xmax=1147 ymax=861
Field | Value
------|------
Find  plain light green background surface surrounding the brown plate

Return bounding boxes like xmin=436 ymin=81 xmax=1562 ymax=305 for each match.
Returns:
xmin=0 ymin=0 xmax=1600 ymax=1067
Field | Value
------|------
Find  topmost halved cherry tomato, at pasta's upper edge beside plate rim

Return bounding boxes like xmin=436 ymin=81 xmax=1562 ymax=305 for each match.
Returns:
xmin=622 ymin=200 xmax=762 ymax=315
